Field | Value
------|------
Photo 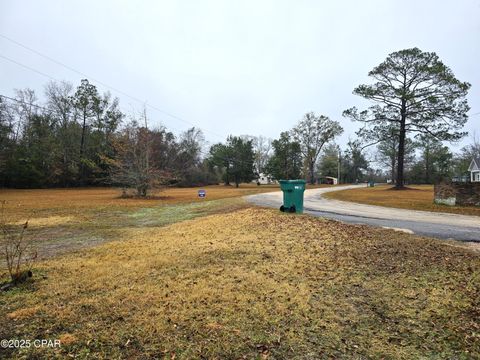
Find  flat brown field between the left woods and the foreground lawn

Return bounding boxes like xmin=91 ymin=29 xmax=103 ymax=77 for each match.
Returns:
xmin=0 ymin=184 xmax=278 ymax=266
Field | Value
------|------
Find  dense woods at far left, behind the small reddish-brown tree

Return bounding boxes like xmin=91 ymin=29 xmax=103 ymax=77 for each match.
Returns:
xmin=0 ymin=80 xmax=220 ymax=188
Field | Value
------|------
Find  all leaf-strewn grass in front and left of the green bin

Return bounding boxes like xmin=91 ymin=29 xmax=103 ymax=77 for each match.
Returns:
xmin=0 ymin=188 xmax=480 ymax=359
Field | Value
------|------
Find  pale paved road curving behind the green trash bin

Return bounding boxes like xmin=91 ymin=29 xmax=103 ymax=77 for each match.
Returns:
xmin=245 ymin=185 xmax=480 ymax=242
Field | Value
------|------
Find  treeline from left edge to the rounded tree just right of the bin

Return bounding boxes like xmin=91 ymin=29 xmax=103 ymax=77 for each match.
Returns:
xmin=0 ymin=80 xmax=360 ymax=191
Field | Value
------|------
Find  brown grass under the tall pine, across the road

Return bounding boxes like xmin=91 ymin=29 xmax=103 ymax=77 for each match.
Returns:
xmin=323 ymin=185 xmax=480 ymax=216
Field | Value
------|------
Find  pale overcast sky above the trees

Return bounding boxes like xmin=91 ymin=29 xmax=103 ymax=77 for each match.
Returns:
xmin=0 ymin=0 xmax=480 ymax=148
